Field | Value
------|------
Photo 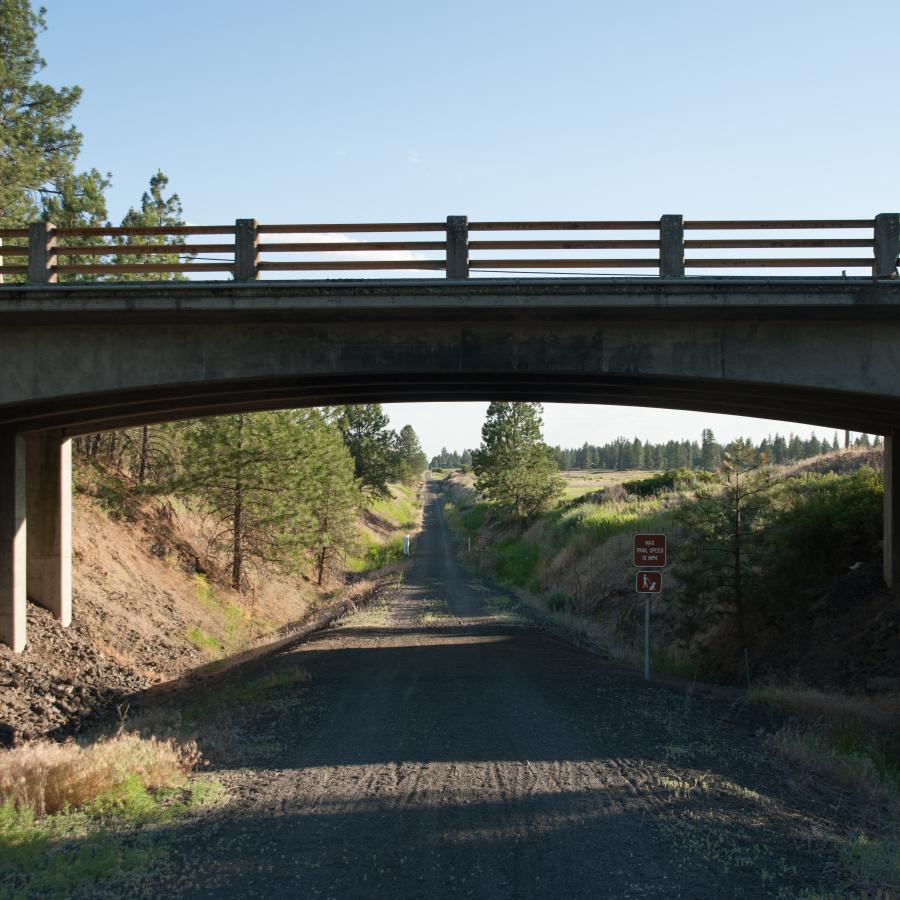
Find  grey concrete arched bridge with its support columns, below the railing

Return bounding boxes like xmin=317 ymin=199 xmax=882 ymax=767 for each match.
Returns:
xmin=0 ymin=216 xmax=900 ymax=650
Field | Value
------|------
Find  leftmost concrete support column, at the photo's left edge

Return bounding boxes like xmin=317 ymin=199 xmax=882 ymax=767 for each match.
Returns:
xmin=0 ymin=428 xmax=25 ymax=653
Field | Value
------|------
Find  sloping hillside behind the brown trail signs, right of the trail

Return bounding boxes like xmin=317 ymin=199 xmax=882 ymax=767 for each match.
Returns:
xmin=445 ymin=450 xmax=900 ymax=690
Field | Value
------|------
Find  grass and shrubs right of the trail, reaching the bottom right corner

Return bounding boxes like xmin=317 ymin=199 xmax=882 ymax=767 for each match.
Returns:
xmin=442 ymin=406 xmax=900 ymax=896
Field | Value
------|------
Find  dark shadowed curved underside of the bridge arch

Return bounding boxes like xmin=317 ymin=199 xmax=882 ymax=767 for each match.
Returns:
xmin=0 ymin=372 xmax=900 ymax=437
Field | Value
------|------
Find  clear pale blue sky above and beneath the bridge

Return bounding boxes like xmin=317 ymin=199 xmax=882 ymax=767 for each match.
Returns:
xmin=40 ymin=0 xmax=900 ymax=452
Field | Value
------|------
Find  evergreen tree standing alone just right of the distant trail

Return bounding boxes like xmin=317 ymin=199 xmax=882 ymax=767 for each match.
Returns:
xmin=472 ymin=402 xmax=564 ymax=520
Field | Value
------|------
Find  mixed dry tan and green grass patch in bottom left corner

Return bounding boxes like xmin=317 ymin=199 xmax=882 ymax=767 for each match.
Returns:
xmin=0 ymin=732 xmax=223 ymax=897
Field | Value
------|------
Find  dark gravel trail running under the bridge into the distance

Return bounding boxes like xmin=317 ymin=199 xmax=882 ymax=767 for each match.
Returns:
xmin=114 ymin=486 xmax=852 ymax=900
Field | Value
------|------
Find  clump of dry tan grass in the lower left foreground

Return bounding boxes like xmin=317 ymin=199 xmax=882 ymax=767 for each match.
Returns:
xmin=0 ymin=733 xmax=200 ymax=816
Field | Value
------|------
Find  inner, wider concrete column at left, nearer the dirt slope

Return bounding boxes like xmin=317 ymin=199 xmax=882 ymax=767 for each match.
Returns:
xmin=25 ymin=432 xmax=72 ymax=627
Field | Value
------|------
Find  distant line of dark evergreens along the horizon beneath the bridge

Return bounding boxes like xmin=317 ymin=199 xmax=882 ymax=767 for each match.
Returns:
xmin=431 ymin=428 xmax=881 ymax=471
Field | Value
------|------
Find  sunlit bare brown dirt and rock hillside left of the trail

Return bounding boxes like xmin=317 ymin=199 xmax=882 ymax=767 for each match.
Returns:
xmin=0 ymin=466 xmax=420 ymax=745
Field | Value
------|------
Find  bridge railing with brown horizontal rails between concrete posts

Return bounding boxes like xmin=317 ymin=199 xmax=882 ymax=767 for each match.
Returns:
xmin=0 ymin=213 xmax=900 ymax=284
